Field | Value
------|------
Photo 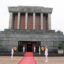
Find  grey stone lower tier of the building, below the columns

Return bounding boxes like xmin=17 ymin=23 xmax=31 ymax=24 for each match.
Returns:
xmin=0 ymin=29 xmax=64 ymax=53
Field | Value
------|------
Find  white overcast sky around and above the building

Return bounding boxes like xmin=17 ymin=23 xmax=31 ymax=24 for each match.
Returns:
xmin=0 ymin=0 xmax=64 ymax=32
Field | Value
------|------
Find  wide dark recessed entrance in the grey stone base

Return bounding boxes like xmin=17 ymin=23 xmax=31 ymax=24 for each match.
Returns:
xmin=18 ymin=41 xmax=41 ymax=53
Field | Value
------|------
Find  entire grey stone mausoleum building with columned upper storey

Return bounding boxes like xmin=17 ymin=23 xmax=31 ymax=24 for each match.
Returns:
xmin=0 ymin=6 xmax=64 ymax=53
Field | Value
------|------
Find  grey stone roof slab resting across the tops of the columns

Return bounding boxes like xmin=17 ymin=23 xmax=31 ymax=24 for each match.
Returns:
xmin=8 ymin=6 xmax=52 ymax=13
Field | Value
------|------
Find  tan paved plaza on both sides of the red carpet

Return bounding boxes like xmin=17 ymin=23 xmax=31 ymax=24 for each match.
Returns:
xmin=0 ymin=56 xmax=64 ymax=64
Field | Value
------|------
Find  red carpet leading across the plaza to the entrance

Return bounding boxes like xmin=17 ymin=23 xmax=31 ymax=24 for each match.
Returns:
xmin=18 ymin=52 xmax=36 ymax=64
